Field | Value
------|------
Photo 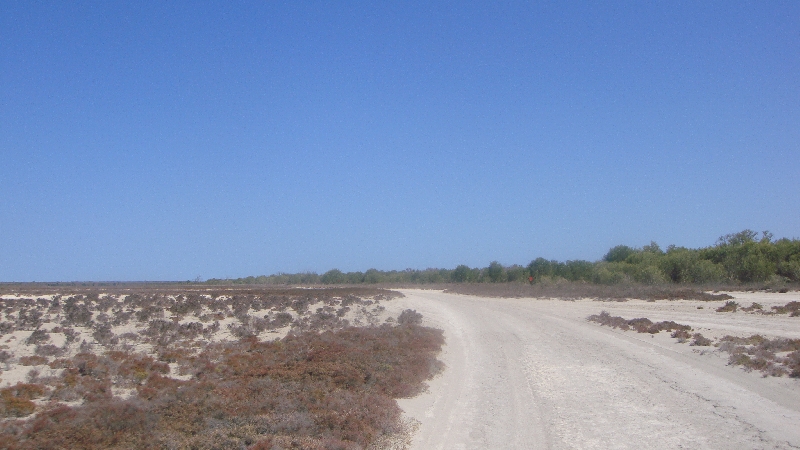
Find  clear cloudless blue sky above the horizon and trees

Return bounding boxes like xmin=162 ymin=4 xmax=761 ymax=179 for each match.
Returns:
xmin=0 ymin=1 xmax=800 ymax=281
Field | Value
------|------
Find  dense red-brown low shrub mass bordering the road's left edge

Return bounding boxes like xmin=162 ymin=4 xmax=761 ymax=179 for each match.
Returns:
xmin=0 ymin=324 xmax=443 ymax=450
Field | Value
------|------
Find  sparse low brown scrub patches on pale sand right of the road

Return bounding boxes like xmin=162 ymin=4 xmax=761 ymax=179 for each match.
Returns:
xmin=587 ymin=310 xmax=800 ymax=378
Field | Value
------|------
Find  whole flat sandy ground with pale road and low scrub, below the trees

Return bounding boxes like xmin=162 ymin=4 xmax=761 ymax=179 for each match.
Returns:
xmin=0 ymin=288 xmax=800 ymax=449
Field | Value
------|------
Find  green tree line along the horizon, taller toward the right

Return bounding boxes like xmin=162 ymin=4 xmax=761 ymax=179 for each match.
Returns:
xmin=206 ymin=230 xmax=800 ymax=285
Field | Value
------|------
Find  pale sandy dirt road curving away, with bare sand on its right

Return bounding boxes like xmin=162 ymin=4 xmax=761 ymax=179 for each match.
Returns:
xmin=393 ymin=290 xmax=800 ymax=450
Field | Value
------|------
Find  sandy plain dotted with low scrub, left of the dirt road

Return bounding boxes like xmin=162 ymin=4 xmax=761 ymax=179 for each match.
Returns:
xmin=0 ymin=287 xmax=443 ymax=449
